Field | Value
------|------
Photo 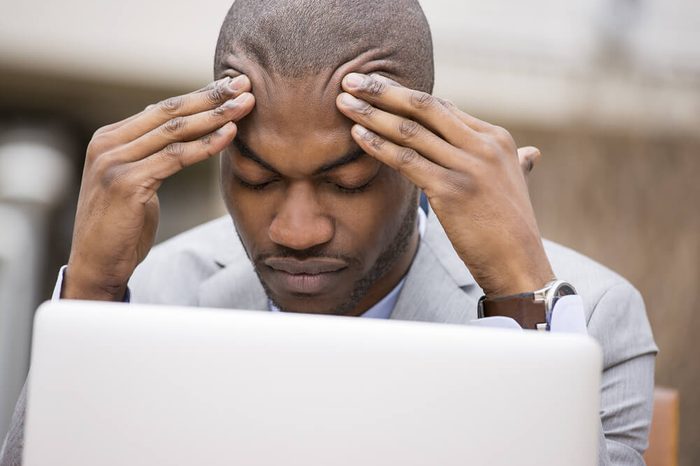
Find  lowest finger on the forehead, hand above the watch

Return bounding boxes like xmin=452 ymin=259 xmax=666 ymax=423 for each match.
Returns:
xmin=351 ymin=125 xmax=446 ymax=191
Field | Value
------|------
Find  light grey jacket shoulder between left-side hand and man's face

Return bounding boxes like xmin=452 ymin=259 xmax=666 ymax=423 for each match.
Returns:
xmin=129 ymin=216 xmax=245 ymax=306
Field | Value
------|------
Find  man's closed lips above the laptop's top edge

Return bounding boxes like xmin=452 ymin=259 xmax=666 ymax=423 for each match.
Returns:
xmin=263 ymin=257 xmax=348 ymax=295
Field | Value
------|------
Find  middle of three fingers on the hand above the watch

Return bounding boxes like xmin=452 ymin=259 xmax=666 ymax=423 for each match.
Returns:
xmin=337 ymin=92 xmax=464 ymax=169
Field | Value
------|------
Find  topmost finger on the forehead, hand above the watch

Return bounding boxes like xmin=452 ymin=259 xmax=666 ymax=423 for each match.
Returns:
xmin=342 ymin=73 xmax=474 ymax=147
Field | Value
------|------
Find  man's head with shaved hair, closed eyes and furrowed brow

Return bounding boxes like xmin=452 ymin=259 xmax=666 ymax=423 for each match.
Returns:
xmin=215 ymin=0 xmax=433 ymax=314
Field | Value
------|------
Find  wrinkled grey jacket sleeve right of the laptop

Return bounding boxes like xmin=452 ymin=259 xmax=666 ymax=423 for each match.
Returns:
xmin=588 ymin=283 xmax=657 ymax=466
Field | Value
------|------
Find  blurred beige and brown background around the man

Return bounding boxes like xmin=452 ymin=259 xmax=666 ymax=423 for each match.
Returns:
xmin=0 ymin=0 xmax=700 ymax=466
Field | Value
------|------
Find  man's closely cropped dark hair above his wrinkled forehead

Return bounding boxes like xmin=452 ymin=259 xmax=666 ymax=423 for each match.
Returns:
xmin=214 ymin=0 xmax=434 ymax=92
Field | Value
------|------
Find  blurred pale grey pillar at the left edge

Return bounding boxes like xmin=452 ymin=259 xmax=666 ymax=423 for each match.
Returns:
xmin=0 ymin=126 xmax=73 ymax=439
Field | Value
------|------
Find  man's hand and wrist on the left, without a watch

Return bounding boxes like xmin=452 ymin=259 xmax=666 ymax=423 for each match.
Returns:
xmin=61 ymin=76 xmax=255 ymax=301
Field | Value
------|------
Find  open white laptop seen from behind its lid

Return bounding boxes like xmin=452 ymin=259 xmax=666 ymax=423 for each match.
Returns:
xmin=24 ymin=301 xmax=602 ymax=466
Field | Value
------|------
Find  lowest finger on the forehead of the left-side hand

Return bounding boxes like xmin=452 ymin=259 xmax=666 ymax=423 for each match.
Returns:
xmin=136 ymin=122 xmax=238 ymax=182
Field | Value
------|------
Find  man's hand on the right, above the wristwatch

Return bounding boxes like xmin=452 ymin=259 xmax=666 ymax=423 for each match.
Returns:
xmin=337 ymin=73 xmax=554 ymax=297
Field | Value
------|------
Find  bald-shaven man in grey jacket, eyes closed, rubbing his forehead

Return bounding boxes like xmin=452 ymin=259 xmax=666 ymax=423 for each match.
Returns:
xmin=1 ymin=0 xmax=656 ymax=466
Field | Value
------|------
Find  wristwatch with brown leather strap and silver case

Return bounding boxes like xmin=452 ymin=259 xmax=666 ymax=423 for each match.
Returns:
xmin=478 ymin=280 xmax=577 ymax=330
